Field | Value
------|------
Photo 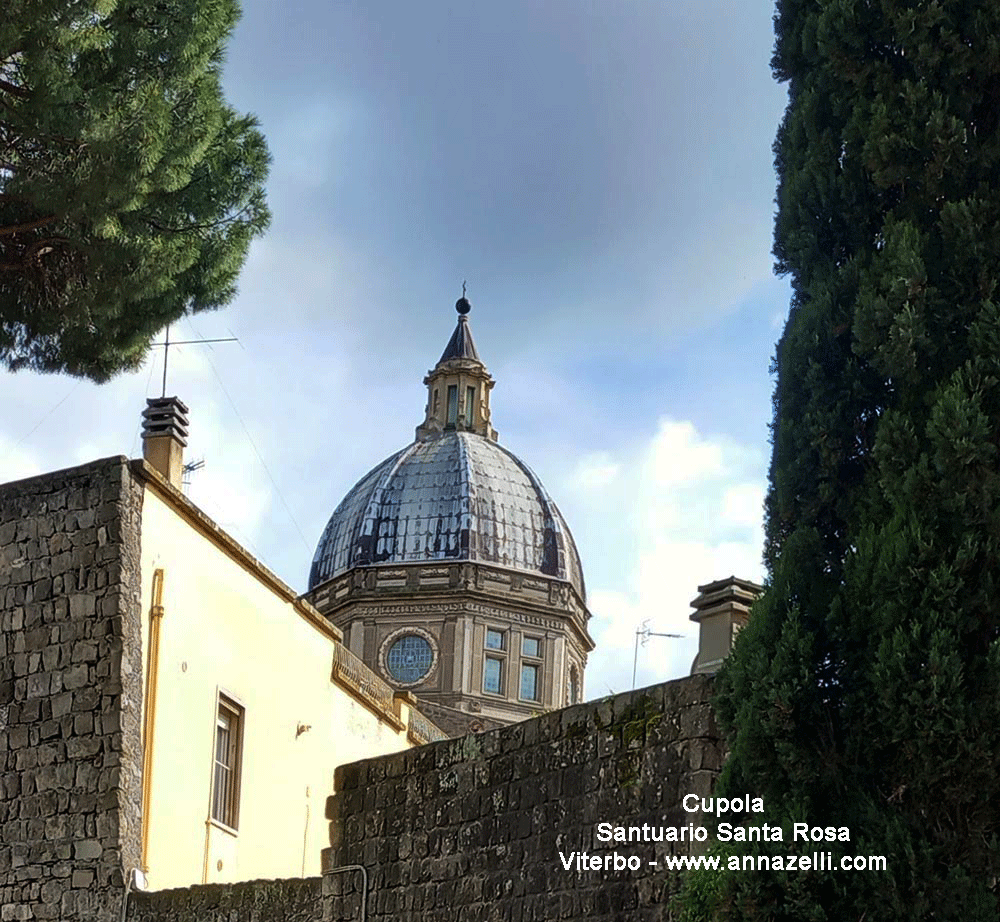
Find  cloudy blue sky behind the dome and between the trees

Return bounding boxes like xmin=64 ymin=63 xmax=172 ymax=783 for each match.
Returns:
xmin=0 ymin=0 xmax=789 ymax=697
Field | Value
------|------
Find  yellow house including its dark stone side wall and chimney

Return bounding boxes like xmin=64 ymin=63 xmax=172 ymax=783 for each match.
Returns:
xmin=0 ymin=398 xmax=444 ymax=904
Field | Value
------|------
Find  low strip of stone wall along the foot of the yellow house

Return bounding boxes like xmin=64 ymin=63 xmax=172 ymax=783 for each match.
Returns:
xmin=126 ymin=877 xmax=322 ymax=922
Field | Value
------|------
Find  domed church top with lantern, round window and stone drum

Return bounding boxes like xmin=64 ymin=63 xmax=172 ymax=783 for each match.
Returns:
xmin=306 ymin=297 xmax=594 ymax=734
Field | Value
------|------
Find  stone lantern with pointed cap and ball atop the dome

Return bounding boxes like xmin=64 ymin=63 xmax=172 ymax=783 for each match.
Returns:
xmin=417 ymin=282 xmax=497 ymax=442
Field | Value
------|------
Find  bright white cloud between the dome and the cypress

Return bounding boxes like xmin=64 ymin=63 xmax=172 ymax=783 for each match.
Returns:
xmin=570 ymin=418 xmax=765 ymax=697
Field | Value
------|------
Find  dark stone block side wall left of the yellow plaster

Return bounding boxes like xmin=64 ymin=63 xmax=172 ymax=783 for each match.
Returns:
xmin=0 ymin=458 xmax=142 ymax=922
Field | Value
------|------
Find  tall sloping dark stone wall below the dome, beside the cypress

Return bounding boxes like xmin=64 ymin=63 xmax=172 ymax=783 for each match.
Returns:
xmin=324 ymin=676 xmax=722 ymax=922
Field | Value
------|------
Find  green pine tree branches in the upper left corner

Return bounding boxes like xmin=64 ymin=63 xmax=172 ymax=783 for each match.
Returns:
xmin=0 ymin=0 xmax=269 ymax=381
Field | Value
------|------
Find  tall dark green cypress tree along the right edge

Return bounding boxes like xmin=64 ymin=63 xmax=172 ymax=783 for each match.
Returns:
xmin=718 ymin=0 xmax=1000 ymax=922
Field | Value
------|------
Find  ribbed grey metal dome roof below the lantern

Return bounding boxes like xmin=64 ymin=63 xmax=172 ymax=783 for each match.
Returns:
xmin=309 ymin=431 xmax=586 ymax=599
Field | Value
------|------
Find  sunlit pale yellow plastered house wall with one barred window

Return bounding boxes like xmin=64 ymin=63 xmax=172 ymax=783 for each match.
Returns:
xmin=134 ymin=418 xmax=436 ymax=889
